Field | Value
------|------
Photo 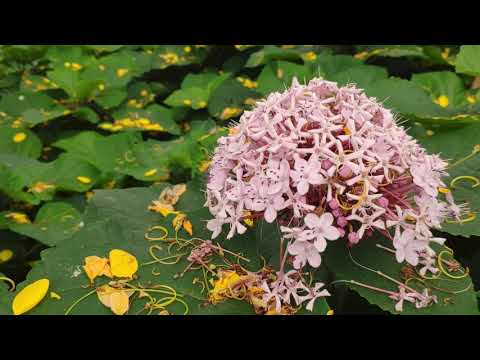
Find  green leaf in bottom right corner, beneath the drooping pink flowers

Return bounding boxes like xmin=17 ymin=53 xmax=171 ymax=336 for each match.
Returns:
xmin=324 ymin=235 xmax=478 ymax=315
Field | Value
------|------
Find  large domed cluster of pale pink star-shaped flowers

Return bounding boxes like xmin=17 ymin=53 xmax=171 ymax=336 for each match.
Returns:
xmin=206 ymin=79 xmax=461 ymax=271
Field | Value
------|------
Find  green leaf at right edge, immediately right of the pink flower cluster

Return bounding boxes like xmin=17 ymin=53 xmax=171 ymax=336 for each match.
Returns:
xmin=410 ymin=124 xmax=480 ymax=237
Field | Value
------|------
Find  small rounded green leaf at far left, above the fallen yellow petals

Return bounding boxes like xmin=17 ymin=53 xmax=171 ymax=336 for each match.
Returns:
xmin=10 ymin=202 xmax=83 ymax=246
